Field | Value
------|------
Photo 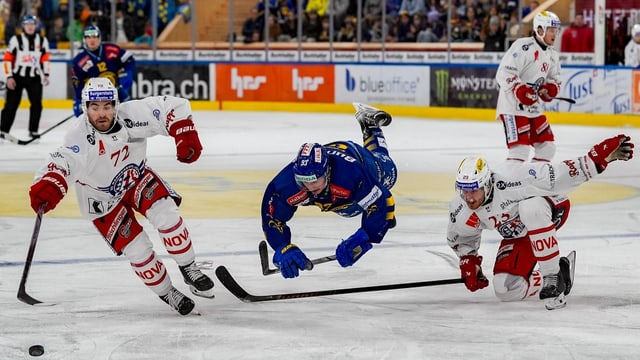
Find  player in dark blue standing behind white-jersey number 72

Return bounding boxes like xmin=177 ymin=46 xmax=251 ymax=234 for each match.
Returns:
xmin=71 ymin=25 xmax=136 ymax=117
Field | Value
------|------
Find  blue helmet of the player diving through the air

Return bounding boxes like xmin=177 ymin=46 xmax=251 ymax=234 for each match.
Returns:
xmin=293 ymin=143 xmax=329 ymax=184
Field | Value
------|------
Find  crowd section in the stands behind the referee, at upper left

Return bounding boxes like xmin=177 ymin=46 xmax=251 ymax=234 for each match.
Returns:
xmin=0 ymin=0 xmax=190 ymax=49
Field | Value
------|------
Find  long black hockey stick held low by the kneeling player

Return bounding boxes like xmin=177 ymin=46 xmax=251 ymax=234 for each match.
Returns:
xmin=216 ymin=266 xmax=464 ymax=302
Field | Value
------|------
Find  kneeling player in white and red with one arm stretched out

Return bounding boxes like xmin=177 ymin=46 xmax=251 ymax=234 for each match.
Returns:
xmin=447 ymin=135 xmax=634 ymax=310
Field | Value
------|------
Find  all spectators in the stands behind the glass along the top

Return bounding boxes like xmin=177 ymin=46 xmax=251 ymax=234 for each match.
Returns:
xmin=0 ymin=0 xmax=630 ymax=64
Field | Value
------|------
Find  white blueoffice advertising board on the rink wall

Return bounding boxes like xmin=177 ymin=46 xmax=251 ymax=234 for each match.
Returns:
xmin=335 ymin=65 xmax=429 ymax=106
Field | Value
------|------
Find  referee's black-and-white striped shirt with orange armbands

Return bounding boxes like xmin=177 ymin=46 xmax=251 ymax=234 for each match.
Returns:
xmin=2 ymin=32 xmax=50 ymax=77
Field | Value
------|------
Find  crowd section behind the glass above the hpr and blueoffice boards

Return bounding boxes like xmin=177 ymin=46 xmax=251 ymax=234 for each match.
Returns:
xmin=241 ymin=0 xmax=537 ymax=51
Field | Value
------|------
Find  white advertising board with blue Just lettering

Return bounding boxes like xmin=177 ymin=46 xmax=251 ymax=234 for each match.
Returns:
xmin=542 ymin=68 xmax=632 ymax=114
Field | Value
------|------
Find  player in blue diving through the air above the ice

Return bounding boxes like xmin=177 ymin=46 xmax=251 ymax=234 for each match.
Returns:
xmin=261 ymin=103 xmax=397 ymax=278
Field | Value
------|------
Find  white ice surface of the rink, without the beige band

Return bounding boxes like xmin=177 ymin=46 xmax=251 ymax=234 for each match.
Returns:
xmin=0 ymin=110 xmax=640 ymax=360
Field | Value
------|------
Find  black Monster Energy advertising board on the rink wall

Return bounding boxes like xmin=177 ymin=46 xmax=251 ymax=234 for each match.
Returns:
xmin=431 ymin=67 xmax=498 ymax=109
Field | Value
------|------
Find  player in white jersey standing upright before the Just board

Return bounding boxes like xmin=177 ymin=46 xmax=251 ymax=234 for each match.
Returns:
xmin=496 ymin=11 xmax=560 ymax=162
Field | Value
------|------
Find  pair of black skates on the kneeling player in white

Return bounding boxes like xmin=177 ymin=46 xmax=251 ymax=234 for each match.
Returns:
xmin=540 ymin=251 xmax=576 ymax=310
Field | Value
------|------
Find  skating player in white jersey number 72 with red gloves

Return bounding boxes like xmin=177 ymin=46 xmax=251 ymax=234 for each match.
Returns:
xmin=29 ymin=78 xmax=213 ymax=315
